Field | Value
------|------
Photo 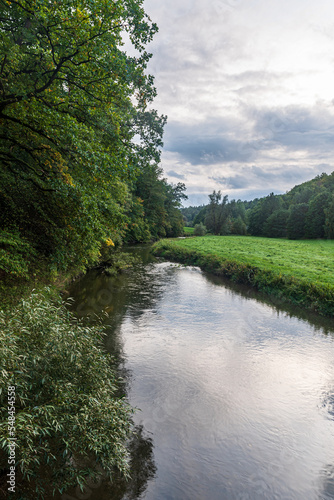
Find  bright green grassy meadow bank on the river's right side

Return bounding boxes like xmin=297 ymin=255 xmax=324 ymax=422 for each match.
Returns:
xmin=154 ymin=236 xmax=334 ymax=316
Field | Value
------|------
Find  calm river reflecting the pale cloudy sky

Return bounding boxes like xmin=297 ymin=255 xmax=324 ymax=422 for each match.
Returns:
xmin=65 ymin=249 xmax=334 ymax=500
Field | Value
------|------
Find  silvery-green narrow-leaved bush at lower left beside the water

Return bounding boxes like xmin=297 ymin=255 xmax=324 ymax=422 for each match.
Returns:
xmin=0 ymin=290 xmax=131 ymax=499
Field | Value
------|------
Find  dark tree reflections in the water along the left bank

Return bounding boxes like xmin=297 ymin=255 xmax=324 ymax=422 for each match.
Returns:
xmin=64 ymin=247 xmax=163 ymax=500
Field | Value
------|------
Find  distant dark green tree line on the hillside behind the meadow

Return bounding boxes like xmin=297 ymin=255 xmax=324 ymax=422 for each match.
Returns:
xmin=182 ymin=172 xmax=334 ymax=239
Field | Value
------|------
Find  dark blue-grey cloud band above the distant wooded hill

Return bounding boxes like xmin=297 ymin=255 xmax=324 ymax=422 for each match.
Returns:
xmin=165 ymin=103 xmax=334 ymax=166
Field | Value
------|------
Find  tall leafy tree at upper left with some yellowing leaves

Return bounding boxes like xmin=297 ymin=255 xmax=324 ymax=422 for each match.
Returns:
xmin=0 ymin=0 xmax=165 ymax=274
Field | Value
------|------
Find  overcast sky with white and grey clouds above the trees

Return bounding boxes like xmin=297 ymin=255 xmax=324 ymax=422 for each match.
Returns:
xmin=144 ymin=0 xmax=334 ymax=205
